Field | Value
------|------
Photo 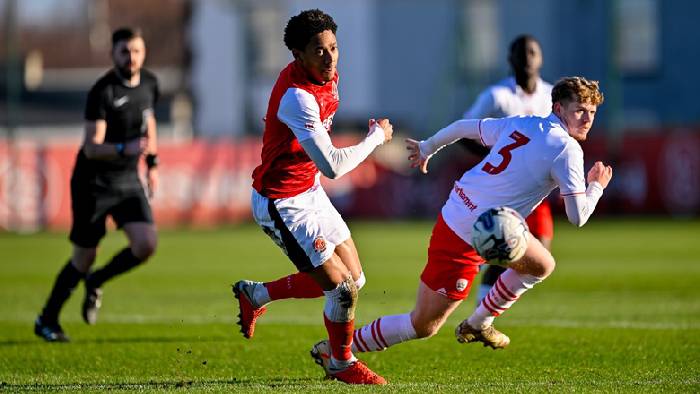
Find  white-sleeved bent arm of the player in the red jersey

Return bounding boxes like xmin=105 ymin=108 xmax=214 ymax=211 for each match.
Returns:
xmin=277 ymin=89 xmax=393 ymax=179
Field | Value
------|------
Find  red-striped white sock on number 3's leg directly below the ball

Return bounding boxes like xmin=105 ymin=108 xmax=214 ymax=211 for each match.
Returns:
xmin=468 ymin=268 xmax=543 ymax=330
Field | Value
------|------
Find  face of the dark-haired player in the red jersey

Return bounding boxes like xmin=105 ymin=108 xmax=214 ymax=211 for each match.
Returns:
xmin=294 ymin=30 xmax=338 ymax=83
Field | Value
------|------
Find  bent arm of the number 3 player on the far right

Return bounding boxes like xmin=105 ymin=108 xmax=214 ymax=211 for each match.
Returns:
xmin=552 ymin=148 xmax=612 ymax=227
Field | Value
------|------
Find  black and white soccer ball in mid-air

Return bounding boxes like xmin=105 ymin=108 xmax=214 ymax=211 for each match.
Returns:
xmin=472 ymin=207 xmax=530 ymax=265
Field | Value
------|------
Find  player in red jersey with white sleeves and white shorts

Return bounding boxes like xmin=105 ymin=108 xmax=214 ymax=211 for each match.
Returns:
xmin=233 ymin=9 xmax=393 ymax=384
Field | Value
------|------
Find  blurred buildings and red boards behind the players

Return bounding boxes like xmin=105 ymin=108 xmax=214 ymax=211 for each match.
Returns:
xmin=0 ymin=0 xmax=700 ymax=230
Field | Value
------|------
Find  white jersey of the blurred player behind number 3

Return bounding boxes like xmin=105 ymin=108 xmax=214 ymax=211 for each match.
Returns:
xmin=462 ymin=77 xmax=552 ymax=119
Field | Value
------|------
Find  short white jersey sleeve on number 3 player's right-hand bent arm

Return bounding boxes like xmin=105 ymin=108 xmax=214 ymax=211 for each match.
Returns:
xmin=551 ymin=141 xmax=586 ymax=197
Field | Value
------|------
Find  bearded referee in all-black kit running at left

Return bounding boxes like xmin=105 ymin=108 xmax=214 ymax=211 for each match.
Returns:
xmin=34 ymin=28 xmax=159 ymax=342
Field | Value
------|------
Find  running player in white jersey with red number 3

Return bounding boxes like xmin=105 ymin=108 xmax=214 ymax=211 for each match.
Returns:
xmin=311 ymin=77 xmax=612 ymax=370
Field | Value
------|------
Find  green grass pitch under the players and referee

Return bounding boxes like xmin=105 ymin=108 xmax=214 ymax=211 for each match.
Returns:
xmin=0 ymin=218 xmax=700 ymax=393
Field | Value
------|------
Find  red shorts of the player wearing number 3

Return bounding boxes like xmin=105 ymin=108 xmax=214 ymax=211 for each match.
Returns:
xmin=420 ymin=215 xmax=484 ymax=300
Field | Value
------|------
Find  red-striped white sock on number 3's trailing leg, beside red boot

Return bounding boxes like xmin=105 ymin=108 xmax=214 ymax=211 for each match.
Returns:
xmin=352 ymin=313 xmax=417 ymax=352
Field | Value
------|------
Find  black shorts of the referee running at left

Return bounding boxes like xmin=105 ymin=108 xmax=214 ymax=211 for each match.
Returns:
xmin=70 ymin=180 xmax=153 ymax=248
